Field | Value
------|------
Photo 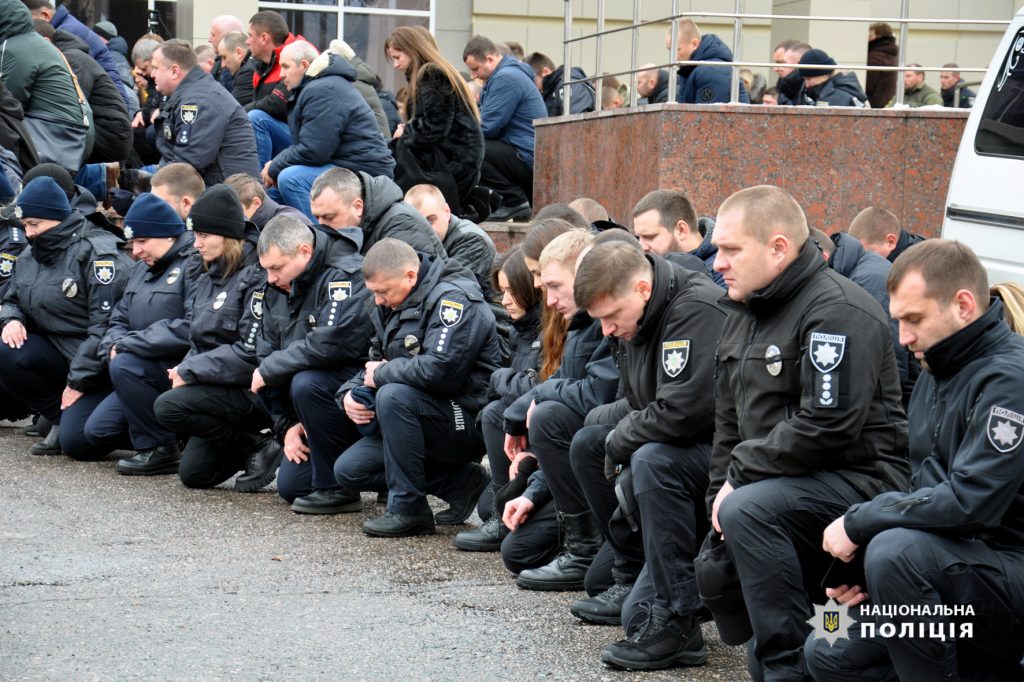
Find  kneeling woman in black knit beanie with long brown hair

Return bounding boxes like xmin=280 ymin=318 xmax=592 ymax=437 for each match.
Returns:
xmin=150 ymin=183 xmax=278 ymax=485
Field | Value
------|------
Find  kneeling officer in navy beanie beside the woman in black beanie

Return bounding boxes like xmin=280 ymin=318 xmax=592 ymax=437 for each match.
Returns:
xmin=85 ymin=194 xmax=202 ymax=475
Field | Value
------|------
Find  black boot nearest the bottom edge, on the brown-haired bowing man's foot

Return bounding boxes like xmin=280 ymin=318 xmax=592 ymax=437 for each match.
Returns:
xmin=601 ymin=606 xmax=708 ymax=670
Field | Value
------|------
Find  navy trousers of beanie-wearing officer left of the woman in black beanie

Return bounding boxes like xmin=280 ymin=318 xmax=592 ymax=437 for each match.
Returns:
xmin=85 ymin=352 xmax=177 ymax=451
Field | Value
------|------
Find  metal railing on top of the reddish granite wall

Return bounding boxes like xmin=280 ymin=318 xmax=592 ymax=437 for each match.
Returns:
xmin=562 ymin=0 xmax=1011 ymax=115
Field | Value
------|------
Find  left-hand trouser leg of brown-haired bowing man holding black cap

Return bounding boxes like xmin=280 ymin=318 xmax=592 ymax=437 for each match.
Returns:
xmin=569 ymin=424 xmax=644 ymax=583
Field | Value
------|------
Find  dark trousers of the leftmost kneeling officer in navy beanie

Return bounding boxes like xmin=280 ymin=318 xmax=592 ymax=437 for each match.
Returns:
xmin=0 ymin=332 xmax=111 ymax=461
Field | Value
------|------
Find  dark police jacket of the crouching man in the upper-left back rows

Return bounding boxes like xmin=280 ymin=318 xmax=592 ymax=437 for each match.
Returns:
xmin=155 ymin=67 xmax=260 ymax=186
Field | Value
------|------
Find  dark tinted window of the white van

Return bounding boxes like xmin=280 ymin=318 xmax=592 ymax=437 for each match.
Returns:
xmin=974 ymin=28 xmax=1024 ymax=159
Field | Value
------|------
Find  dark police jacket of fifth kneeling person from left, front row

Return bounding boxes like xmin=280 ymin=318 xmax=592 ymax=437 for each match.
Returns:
xmin=338 ymin=249 xmax=501 ymax=413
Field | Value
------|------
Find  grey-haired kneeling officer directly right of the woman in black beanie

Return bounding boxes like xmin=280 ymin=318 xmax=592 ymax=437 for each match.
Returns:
xmin=251 ymin=215 xmax=373 ymax=501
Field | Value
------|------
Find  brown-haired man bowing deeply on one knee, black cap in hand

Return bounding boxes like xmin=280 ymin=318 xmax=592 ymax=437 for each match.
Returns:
xmin=569 ymin=242 xmax=725 ymax=670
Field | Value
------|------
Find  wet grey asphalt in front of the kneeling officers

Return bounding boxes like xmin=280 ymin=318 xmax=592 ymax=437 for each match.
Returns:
xmin=0 ymin=426 xmax=746 ymax=680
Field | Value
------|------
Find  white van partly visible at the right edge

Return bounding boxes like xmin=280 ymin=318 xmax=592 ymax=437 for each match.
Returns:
xmin=942 ymin=9 xmax=1024 ymax=285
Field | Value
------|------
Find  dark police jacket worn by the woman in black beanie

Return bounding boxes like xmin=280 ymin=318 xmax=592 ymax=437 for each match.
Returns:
xmin=178 ymin=222 xmax=266 ymax=387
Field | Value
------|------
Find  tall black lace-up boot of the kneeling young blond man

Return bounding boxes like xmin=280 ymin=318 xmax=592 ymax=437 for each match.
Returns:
xmin=515 ymin=510 xmax=603 ymax=592
